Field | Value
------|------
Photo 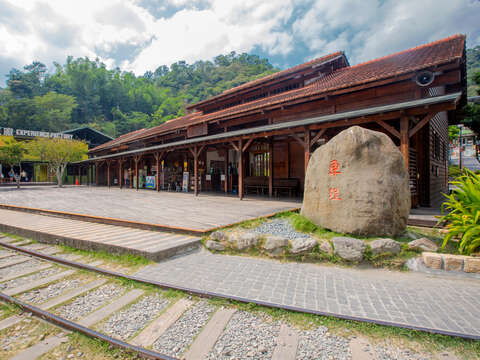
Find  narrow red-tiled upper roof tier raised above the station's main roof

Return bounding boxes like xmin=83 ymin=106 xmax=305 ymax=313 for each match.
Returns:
xmin=187 ymin=51 xmax=345 ymax=109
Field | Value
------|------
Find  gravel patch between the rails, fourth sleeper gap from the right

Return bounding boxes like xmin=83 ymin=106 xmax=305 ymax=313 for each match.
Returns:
xmin=103 ymin=294 xmax=169 ymax=340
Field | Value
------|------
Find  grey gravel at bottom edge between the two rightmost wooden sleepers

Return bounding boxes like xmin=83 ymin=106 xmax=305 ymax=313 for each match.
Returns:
xmin=296 ymin=326 xmax=351 ymax=360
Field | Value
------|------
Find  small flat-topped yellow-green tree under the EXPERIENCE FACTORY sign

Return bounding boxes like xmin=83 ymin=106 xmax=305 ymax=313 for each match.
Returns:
xmin=30 ymin=138 xmax=88 ymax=187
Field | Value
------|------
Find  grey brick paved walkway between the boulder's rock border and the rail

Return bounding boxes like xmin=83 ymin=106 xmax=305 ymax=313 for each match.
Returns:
xmin=137 ymin=250 xmax=480 ymax=338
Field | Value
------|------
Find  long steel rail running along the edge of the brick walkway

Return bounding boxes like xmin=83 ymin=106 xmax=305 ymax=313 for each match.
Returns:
xmin=0 ymin=241 xmax=480 ymax=340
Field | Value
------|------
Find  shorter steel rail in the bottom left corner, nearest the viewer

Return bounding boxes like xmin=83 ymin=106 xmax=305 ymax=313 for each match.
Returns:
xmin=0 ymin=292 xmax=178 ymax=360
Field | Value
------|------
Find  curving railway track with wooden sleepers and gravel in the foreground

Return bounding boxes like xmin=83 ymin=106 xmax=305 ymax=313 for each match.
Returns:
xmin=0 ymin=238 xmax=466 ymax=360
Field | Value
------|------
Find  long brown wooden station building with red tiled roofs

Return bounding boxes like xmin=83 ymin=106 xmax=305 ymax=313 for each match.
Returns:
xmin=82 ymin=35 xmax=466 ymax=206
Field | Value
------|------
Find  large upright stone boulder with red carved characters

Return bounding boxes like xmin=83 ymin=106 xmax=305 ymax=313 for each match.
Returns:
xmin=302 ymin=126 xmax=410 ymax=236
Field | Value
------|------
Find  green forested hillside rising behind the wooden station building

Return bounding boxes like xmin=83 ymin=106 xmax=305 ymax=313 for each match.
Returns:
xmin=0 ymin=52 xmax=278 ymax=137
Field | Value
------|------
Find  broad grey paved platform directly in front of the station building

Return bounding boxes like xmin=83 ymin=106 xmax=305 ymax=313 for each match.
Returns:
xmin=0 ymin=186 xmax=301 ymax=230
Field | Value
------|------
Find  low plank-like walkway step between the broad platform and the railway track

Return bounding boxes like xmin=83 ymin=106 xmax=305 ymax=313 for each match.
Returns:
xmin=0 ymin=209 xmax=200 ymax=262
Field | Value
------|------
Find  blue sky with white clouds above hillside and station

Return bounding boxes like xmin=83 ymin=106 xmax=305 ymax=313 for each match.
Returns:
xmin=0 ymin=0 xmax=480 ymax=84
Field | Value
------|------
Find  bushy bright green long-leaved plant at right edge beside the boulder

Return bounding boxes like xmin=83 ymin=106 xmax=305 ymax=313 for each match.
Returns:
xmin=440 ymin=169 xmax=480 ymax=255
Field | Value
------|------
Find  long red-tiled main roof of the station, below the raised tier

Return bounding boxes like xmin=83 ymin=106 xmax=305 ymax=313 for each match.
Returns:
xmin=93 ymin=35 xmax=465 ymax=151
